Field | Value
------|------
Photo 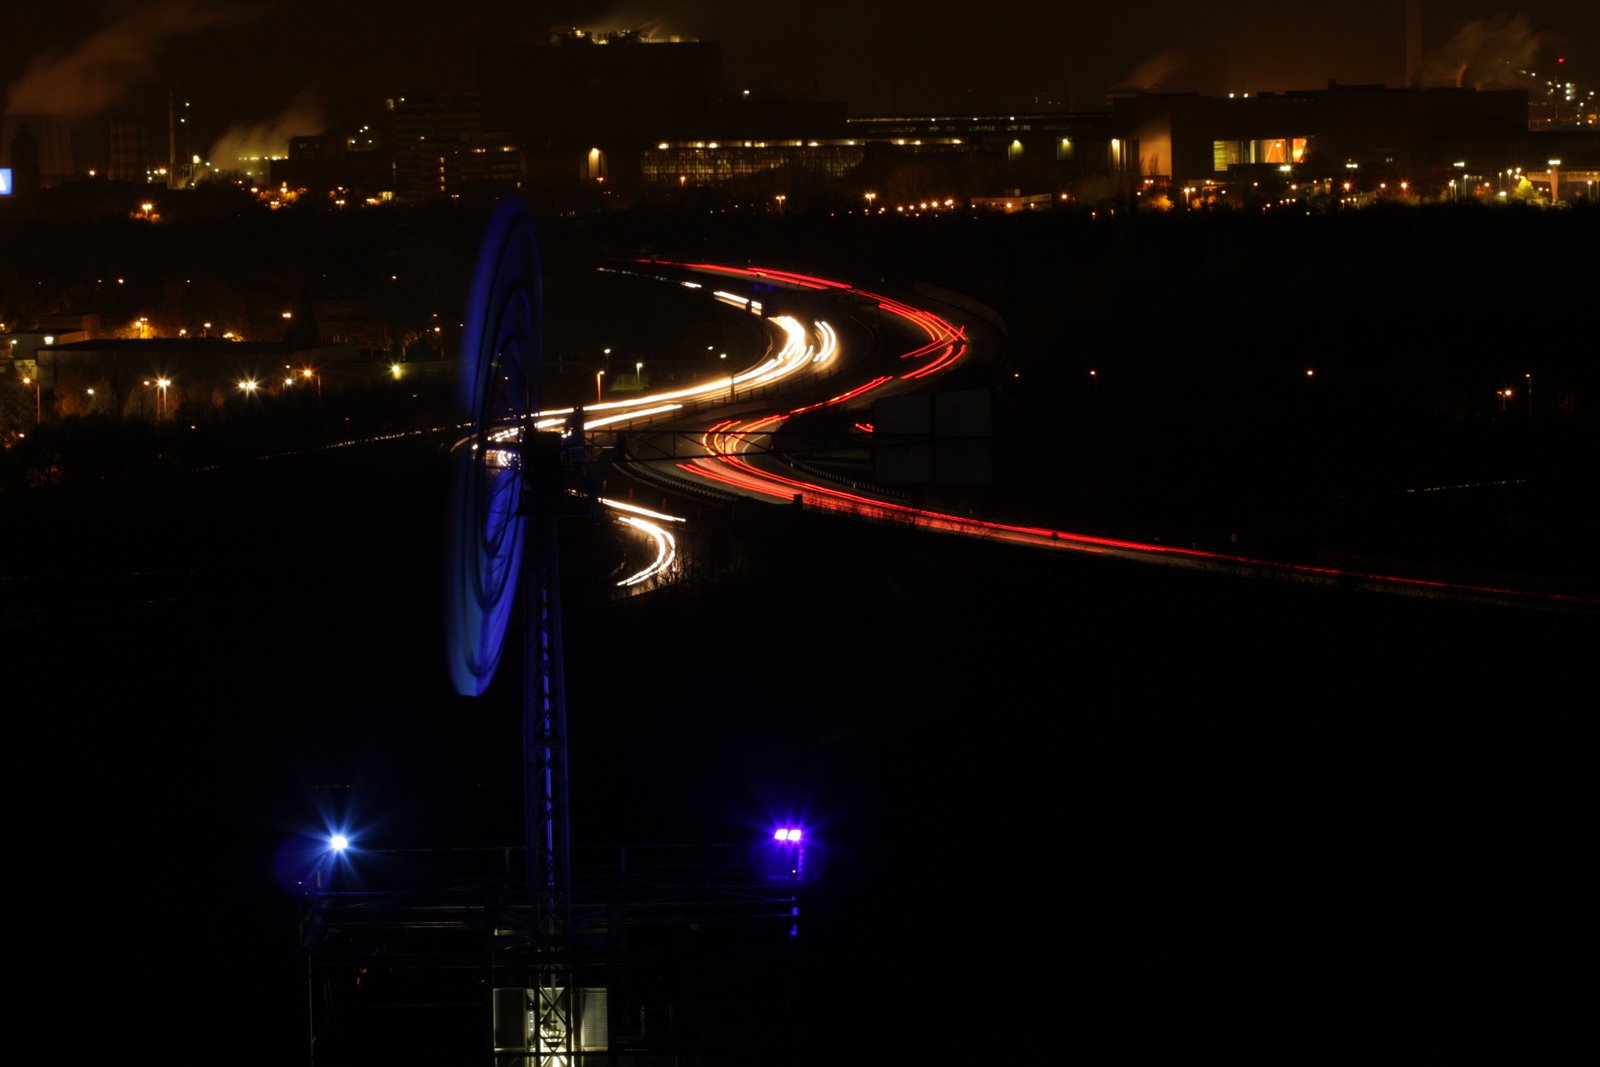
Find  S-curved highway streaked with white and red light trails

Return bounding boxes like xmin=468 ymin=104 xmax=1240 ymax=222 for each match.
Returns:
xmin=536 ymin=261 xmax=1600 ymax=611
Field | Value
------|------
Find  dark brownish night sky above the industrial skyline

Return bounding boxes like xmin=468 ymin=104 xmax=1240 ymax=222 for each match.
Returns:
xmin=0 ymin=0 xmax=1600 ymax=150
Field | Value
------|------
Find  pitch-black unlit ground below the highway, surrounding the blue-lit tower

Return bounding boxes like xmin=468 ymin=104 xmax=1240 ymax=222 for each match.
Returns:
xmin=0 ymin=428 xmax=1600 ymax=1062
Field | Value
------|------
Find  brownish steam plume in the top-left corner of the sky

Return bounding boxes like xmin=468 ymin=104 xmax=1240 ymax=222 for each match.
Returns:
xmin=5 ymin=0 xmax=256 ymax=118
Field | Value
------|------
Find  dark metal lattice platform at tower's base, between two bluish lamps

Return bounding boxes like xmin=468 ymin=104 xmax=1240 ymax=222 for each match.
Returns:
xmin=301 ymin=845 xmax=800 ymax=1067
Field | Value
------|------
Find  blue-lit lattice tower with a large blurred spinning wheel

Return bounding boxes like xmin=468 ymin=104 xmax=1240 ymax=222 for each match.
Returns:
xmin=446 ymin=198 xmax=576 ymax=1065
